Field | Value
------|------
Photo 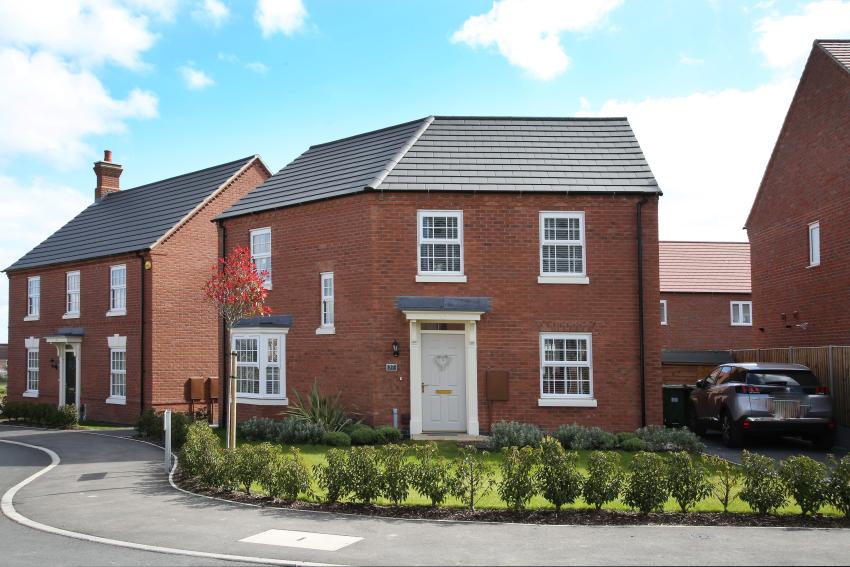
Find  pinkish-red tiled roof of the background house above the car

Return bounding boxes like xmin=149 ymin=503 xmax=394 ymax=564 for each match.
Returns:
xmin=658 ymin=241 xmax=752 ymax=293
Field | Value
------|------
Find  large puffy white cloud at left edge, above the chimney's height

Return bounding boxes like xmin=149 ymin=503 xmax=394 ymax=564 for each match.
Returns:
xmin=0 ymin=48 xmax=158 ymax=165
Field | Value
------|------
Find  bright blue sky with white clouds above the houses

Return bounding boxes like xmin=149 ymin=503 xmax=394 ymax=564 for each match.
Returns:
xmin=0 ymin=0 xmax=850 ymax=342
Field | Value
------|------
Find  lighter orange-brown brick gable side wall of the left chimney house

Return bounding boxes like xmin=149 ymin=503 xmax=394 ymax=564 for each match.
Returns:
xmin=149 ymin=162 xmax=270 ymax=418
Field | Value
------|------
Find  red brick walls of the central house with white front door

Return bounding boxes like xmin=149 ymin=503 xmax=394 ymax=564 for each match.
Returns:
xmin=220 ymin=192 xmax=661 ymax=431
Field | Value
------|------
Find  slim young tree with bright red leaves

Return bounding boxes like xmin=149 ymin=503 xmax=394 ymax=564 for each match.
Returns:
xmin=204 ymin=247 xmax=271 ymax=448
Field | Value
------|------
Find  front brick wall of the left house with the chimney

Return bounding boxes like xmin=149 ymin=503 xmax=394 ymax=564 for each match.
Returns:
xmin=8 ymin=255 xmax=142 ymax=422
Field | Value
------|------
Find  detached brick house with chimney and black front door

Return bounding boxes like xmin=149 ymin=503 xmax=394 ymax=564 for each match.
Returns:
xmin=6 ymin=151 xmax=270 ymax=423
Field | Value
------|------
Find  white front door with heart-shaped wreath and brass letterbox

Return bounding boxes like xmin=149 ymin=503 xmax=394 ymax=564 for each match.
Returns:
xmin=422 ymin=332 xmax=466 ymax=432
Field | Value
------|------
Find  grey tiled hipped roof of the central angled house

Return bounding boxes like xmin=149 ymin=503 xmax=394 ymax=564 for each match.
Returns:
xmin=221 ymin=116 xmax=660 ymax=218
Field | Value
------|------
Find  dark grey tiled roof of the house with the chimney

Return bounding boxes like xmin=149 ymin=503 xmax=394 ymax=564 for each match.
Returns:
xmin=6 ymin=156 xmax=258 ymax=270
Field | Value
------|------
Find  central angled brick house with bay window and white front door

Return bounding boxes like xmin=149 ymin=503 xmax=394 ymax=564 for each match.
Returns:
xmin=218 ymin=117 xmax=661 ymax=435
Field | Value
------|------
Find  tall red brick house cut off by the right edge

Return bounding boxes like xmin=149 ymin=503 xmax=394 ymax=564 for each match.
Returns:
xmin=746 ymin=40 xmax=850 ymax=347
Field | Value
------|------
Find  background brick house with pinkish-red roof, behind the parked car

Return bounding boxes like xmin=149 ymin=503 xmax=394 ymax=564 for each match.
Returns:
xmin=659 ymin=241 xmax=755 ymax=383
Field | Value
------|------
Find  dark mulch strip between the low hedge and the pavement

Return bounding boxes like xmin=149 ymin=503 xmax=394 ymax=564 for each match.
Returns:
xmin=174 ymin=476 xmax=850 ymax=528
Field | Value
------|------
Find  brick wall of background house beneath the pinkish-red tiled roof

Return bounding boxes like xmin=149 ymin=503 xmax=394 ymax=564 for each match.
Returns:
xmin=656 ymin=292 xmax=759 ymax=350
